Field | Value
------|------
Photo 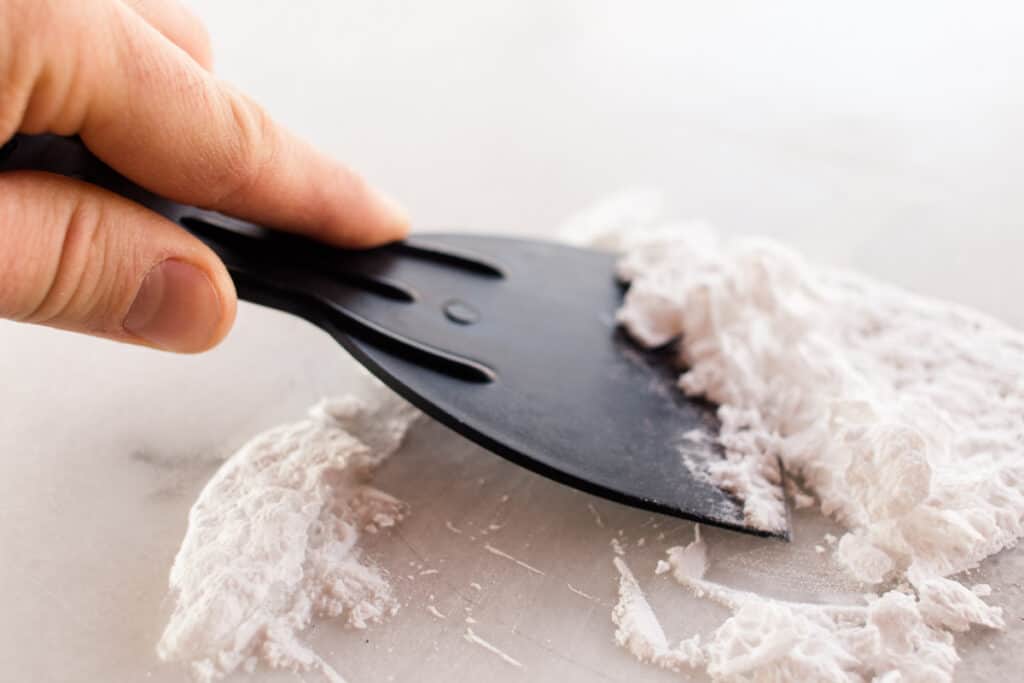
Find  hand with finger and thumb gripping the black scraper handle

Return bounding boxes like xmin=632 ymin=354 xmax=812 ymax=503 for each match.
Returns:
xmin=0 ymin=5 xmax=408 ymax=352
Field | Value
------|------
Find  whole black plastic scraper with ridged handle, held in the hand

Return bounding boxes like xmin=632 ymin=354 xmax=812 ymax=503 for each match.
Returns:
xmin=0 ymin=136 xmax=785 ymax=536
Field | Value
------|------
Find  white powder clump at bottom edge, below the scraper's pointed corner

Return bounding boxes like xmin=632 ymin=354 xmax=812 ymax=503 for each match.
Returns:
xmin=647 ymin=528 xmax=958 ymax=683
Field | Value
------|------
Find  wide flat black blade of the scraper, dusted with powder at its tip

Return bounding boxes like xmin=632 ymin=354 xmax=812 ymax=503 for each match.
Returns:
xmin=311 ymin=234 xmax=787 ymax=538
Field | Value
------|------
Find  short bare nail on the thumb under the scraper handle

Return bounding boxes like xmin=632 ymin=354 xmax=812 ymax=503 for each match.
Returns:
xmin=124 ymin=259 xmax=221 ymax=352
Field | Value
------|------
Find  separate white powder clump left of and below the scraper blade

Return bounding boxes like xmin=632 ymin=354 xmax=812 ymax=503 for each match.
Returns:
xmin=158 ymin=393 xmax=417 ymax=683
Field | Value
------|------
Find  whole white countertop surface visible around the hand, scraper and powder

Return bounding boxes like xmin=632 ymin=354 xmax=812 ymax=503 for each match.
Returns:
xmin=0 ymin=0 xmax=1024 ymax=683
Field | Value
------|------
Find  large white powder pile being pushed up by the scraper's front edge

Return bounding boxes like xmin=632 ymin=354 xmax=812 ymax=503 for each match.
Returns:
xmin=620 ymin=228 xmax=1024 ymax=583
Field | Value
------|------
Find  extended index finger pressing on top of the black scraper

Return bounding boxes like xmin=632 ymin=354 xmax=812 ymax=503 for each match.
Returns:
xmin=35 ymin=2 xmax=408 ymax=247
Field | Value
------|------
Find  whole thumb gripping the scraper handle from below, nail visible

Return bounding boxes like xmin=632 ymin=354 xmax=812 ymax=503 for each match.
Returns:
xmin=0 ymin=172 xmax=236 ymax=353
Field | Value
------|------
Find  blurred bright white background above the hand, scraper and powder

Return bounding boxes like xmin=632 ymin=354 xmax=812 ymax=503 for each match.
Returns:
xmin=191 ymin=0 xmax=1024 ymax=323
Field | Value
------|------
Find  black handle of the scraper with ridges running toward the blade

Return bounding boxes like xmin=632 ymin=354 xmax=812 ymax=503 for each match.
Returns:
xmin=0 ymin=135 xmax=495 ymax=382
